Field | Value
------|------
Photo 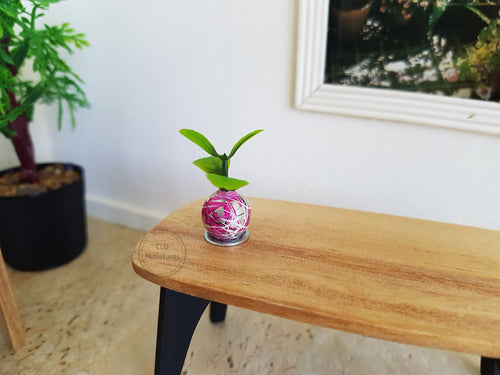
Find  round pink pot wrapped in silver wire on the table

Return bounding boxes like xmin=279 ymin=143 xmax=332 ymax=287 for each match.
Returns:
xmin=201 ymin=190 xmax=250 ymax=246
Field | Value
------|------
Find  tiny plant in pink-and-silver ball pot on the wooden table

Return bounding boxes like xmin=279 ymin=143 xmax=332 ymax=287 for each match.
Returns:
xmin=179 ymin=129 xmax=263 ymax=246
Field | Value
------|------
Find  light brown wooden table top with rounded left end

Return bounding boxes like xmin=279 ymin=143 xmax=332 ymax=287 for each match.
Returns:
xmin=132 ymin=198 xmax=500 ymax=358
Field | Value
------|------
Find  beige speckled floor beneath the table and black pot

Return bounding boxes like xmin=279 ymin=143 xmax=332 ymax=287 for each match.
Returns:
xmin=0 ymin=219 xmax=479 ymax=375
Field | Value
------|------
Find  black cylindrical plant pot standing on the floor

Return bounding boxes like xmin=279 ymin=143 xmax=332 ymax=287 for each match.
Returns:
xmin=0 ymin=163 xmax=87 ymax=271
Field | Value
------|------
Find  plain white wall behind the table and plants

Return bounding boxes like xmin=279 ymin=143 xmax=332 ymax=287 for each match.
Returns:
xmin=0 ymin=0 xmax=500 ymax=229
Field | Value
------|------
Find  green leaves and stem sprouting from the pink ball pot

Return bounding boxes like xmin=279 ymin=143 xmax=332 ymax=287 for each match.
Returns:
xmin=179 ymin=129 xmax=263 ymax=190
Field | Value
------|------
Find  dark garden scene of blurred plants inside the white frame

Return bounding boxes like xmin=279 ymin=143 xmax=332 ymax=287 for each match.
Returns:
xmin=325 ymin=0 xmax=500 ymax=100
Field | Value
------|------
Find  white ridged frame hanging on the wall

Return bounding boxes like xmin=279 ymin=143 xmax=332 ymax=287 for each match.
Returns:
xmin=295 ymin=0 xmax=500 ymax=135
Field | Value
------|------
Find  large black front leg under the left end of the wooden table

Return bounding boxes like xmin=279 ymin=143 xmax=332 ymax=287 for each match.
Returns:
xmin=155 ymin=288 xmax=209 ymax=375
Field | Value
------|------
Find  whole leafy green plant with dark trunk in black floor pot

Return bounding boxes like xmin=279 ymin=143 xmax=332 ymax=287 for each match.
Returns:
xmin=0 ymin=0 xmax=89 ymax=270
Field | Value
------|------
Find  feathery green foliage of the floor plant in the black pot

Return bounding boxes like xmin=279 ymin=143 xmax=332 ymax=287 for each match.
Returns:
xmin=0 ymin=0 xmax=89 ymax=137
